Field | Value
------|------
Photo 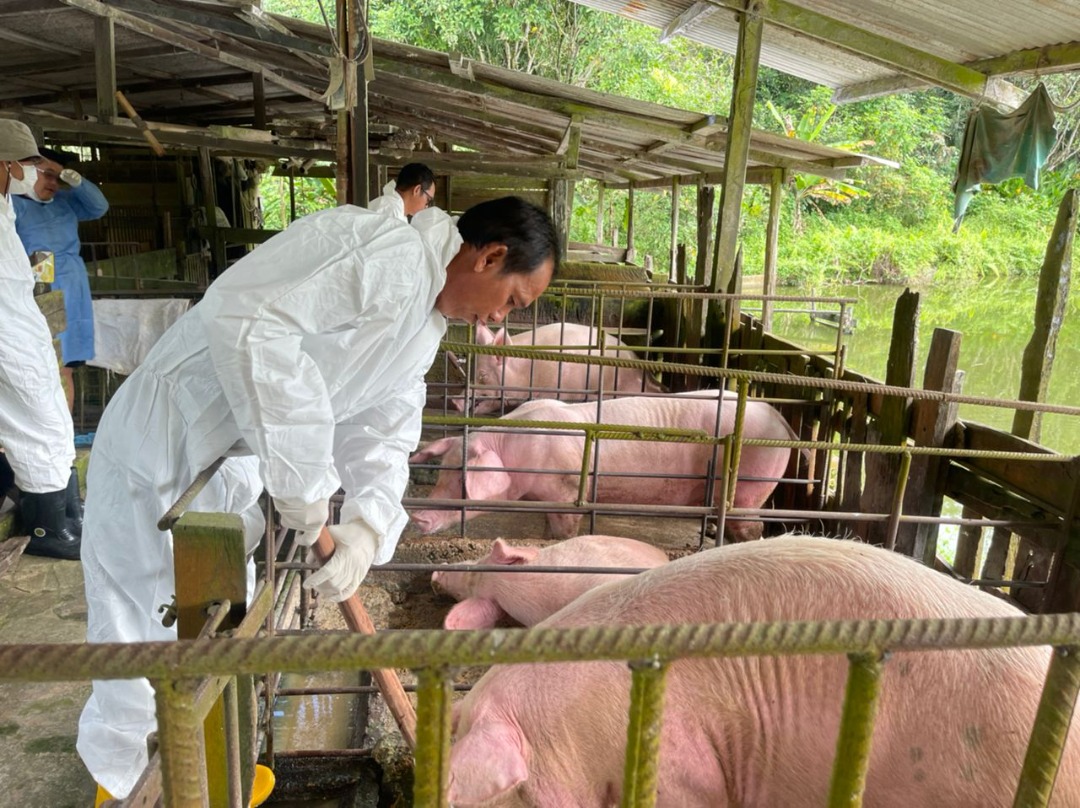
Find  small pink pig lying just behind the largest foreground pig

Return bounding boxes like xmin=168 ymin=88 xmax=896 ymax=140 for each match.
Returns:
xmin=431 ymin=536 xmax=667 ymax=629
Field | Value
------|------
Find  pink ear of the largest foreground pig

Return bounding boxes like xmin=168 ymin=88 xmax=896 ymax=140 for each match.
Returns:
xmin=446 ymin=722 xmax=529 ymax=806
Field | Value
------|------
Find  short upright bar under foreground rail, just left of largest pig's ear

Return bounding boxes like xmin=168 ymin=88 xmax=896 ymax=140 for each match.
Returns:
xmin=414 ymin=668 xmax=453 ymax=808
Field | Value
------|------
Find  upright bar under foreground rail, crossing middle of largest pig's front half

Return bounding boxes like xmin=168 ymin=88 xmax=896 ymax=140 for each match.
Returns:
xmin=622 ymin=658 xmax=667 ymax=808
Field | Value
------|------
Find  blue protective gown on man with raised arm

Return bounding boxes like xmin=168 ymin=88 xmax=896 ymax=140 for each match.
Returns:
xmin=12 ymin=177 xmax=109 ymax=365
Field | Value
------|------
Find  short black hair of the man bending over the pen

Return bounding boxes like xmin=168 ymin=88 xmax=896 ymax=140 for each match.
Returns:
xmin=458 ymin=197 xmax=558 ymax=278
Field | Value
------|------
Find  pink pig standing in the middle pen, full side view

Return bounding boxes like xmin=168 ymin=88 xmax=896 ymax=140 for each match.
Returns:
xmin=409 ymin=391 xmax=794 ymax=540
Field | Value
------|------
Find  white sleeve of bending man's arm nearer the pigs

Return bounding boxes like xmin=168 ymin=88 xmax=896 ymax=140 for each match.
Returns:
xmin=334 ymin=378 xmax=427 ymax=564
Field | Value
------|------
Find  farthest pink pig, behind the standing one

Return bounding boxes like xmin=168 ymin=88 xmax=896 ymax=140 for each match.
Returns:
xmin=451 ymin=323 xmax=662 ymax=415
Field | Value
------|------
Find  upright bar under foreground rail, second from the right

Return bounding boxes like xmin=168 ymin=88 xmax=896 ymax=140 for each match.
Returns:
xmin=828 ymin=654 xmax=885 ymax=808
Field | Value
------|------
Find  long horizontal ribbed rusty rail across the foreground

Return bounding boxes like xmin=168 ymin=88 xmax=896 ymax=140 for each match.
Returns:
xmin=8 ymin=614 xmax=1080 ymax=682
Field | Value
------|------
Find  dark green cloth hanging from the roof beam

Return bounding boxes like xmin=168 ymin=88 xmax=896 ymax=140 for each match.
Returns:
xmin=953 ymin=82 xmax=1056 ymax=232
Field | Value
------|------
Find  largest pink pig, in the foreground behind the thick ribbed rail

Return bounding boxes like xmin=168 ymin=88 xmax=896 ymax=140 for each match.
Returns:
xmin=448 ymin=536 xmax=1080 ymax=808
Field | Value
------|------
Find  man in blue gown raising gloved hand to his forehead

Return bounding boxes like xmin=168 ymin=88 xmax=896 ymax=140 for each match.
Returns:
xmin=12 ymin=144 xmax=109 ymax=412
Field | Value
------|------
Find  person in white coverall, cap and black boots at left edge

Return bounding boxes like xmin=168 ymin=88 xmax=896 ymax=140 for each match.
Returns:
xmin=0 ymin=120 xmax=79 ymax=560
